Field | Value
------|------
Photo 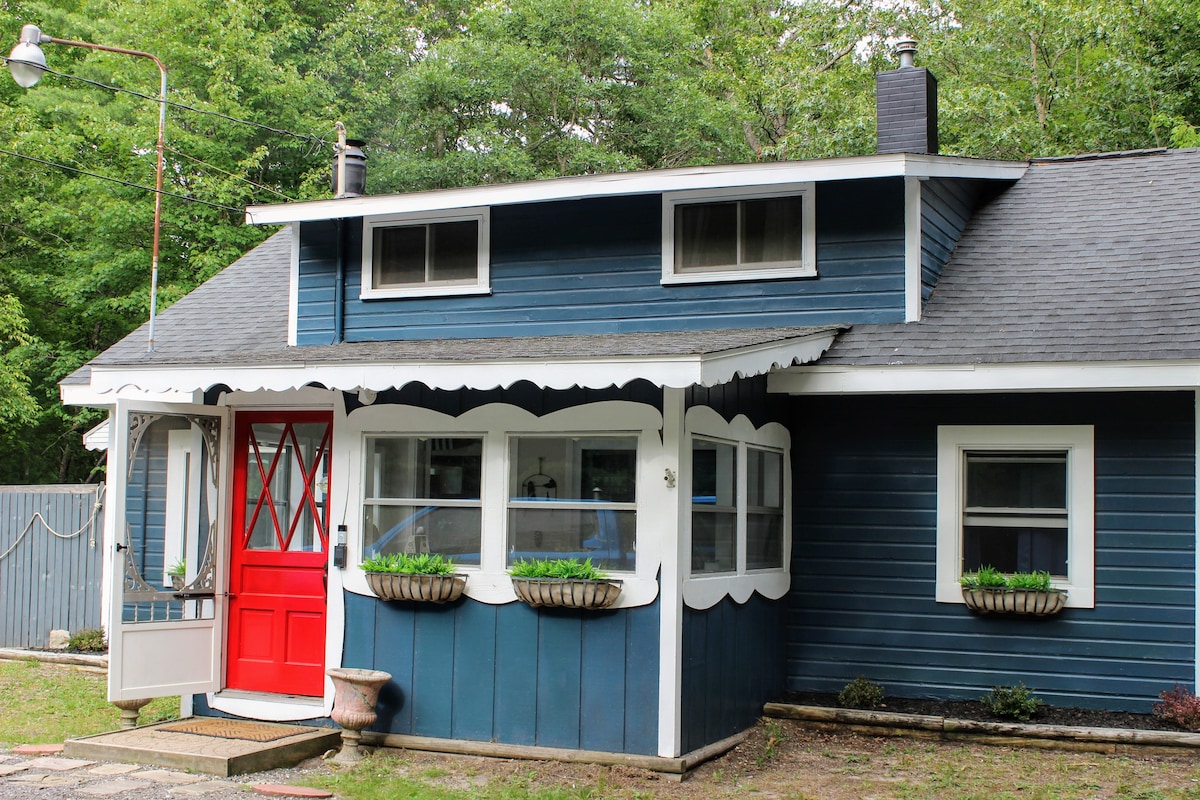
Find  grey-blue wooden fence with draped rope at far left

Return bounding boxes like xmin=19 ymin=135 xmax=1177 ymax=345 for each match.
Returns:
xmin=0 ymin=486 xmax=104 ymax=648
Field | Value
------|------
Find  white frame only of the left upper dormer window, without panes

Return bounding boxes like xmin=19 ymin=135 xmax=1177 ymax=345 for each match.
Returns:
xmin=359 ymin=206 xmax=492 ymax=300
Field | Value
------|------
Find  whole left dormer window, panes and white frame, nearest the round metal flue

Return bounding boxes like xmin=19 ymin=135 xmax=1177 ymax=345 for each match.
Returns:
xmin=361 ymin=207 xmax=491 ymax=299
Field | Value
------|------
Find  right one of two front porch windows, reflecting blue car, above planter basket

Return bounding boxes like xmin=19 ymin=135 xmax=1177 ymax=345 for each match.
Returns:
xmin=505 ymin=434 xmax=637 ymax=572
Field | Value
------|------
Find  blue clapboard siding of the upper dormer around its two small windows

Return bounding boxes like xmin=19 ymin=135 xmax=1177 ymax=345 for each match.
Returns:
xmin=298 ymin=179 xmax=904 ymax=344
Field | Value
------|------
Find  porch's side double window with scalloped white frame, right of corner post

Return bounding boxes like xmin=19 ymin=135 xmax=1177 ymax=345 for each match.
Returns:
xmin=684 ymin=407 xmax=791 ymax=608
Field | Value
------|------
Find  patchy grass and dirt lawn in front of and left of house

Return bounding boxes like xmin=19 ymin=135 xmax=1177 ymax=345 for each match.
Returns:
xmin=0 ymin=661 xmax=1200 ymax=800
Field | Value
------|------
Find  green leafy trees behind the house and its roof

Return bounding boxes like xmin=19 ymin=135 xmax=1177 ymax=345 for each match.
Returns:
xmin=0 ymin=0 xmax=1200 ymax=482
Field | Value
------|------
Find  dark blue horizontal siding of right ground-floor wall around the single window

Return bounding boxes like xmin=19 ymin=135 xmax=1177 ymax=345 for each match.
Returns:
xmin=786 ymin=392 xmax=1196 ymax=712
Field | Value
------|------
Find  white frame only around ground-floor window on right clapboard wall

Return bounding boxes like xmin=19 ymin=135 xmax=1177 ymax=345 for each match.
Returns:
xmin=935 ymin=425 xmax=1096 ymax=608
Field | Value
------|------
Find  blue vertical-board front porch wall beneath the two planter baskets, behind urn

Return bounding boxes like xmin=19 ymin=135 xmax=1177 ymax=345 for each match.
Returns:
xmin=342 ymin=594 xmax=659 ymax=754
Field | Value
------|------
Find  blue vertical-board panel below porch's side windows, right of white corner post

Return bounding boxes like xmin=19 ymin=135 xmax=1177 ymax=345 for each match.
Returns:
xmin=680 ymin=595 xmax=785 ymax=753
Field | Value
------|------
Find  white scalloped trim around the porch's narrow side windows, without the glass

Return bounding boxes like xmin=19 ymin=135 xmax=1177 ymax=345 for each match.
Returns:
xmin=679 ymin=405 xmax=792 ymax=609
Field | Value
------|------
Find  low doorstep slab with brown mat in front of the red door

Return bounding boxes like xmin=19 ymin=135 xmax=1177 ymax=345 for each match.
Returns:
xmin=64 ymin=717 xmax=341 ymax=777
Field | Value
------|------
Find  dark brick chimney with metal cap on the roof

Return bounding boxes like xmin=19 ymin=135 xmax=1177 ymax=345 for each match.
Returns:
xmin=875 ymin=40 xmax=937 ymax=154
